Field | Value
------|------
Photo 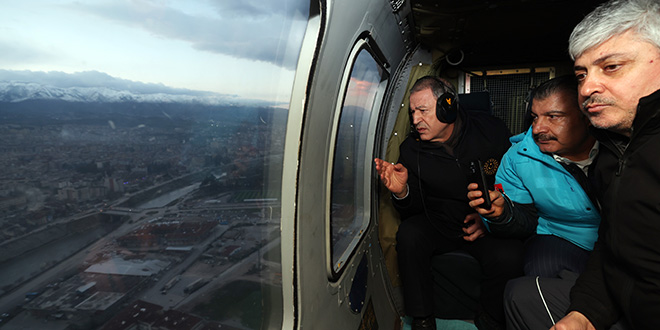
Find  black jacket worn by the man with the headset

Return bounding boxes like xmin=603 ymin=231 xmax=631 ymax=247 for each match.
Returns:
xmin=393 ymin=110 xmax=511 ymax=239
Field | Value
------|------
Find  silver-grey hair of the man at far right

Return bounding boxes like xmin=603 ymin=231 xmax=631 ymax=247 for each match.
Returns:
xmin=568 ymin=0 xmax=660 ymax=60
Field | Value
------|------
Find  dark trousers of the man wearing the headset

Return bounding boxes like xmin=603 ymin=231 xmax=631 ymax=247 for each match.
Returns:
xmin=396 ymin=215 xmax=523 ymax=324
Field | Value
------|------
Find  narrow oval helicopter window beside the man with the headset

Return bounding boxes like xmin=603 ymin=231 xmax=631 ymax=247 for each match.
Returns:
xmin=330 ymin=48 xmax=387 ymax=273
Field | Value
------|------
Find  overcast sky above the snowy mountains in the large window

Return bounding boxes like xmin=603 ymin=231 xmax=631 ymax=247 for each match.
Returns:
xmin=0 ymin=0 xmax=308 ymax=102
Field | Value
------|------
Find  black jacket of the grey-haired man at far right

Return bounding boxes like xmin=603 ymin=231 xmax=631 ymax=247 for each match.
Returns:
xmin=569 ymin=91 xmax=660 ymax=330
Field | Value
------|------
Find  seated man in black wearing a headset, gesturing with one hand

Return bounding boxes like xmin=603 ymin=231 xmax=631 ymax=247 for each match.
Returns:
xmin=375 ymin=76 xmax=522 ymax=330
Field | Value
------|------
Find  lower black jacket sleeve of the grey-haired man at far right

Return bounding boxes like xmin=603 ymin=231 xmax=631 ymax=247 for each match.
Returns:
xmin=567 ymin=223 xmax=620 ymax=330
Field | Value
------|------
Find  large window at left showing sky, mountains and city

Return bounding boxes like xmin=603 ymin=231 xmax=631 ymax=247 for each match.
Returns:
xmin=0 ymin=0 xmax=310 ymax=329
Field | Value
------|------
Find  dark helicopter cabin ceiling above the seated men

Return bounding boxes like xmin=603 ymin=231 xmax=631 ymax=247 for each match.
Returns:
xmin=410 ymin=0 xmax=604 ymax=67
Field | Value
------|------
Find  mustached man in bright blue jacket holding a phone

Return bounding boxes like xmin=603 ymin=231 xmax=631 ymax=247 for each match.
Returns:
xmin=468 ymin=76 xmax=600 ymax=329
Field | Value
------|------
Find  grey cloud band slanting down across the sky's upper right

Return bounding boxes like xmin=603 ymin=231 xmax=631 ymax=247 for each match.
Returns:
xmin=71 ymin=0 xmax=309 ymax=69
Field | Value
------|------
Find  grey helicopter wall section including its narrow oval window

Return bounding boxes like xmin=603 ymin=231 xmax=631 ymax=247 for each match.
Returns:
xmin=290 ymin=0 xmax=409 ymax=329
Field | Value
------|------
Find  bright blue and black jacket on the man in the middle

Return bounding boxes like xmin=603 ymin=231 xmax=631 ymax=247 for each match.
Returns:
xmin=484 ymin=127 xmax=600 ymax=251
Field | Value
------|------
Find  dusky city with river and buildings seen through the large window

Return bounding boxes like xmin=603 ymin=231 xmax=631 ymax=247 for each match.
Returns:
xmin=0 ymin=84 xmax=286 ymax=329
